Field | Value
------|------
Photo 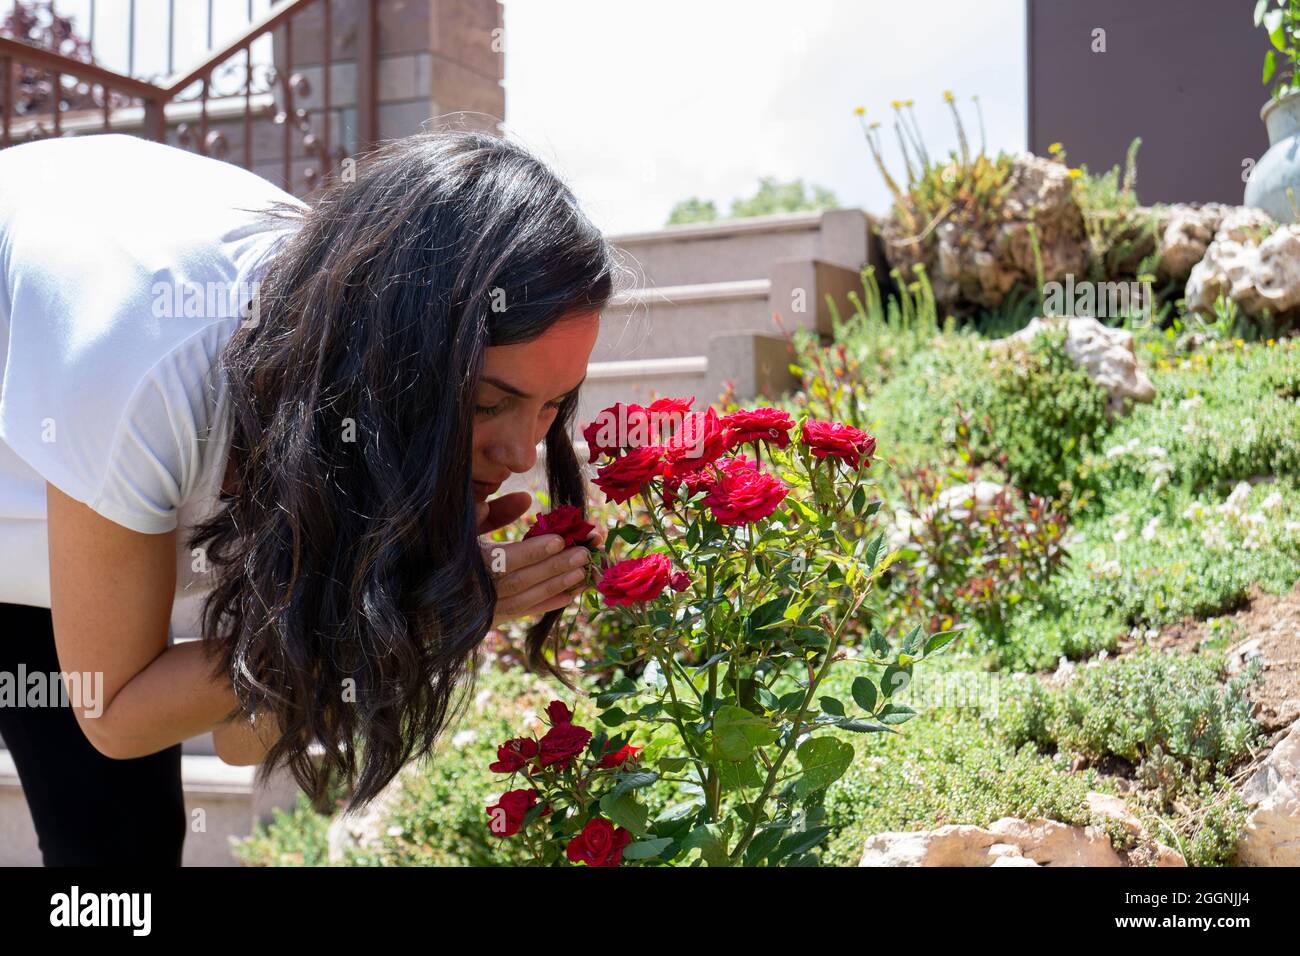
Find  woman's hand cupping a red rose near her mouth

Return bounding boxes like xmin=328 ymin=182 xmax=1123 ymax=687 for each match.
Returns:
xmin=478 ymin=492 xmax=607 ymax=627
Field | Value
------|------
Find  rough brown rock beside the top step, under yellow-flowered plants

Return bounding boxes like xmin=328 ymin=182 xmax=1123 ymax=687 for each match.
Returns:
xmin=880 ymin=153 xmax=1088 ymax=311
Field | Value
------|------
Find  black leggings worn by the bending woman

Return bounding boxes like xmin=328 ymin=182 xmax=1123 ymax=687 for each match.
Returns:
xmin=0 ymin=604 xmax=186 ymax=866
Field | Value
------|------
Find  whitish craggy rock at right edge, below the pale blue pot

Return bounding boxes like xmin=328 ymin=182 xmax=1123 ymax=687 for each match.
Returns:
xmin=1184 ymin=222 xmax=1300 ymax=319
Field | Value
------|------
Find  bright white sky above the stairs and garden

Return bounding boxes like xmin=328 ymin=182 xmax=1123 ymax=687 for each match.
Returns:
xmin=10 ymin=0 xmax=1026 ymax=233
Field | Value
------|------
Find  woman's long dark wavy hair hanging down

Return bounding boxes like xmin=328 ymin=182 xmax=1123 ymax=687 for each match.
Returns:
xmin=190 ymin=130 xmax=618 ymax=810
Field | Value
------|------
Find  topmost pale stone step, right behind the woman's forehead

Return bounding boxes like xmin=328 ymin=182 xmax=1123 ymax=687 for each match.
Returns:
xmin=610 ymin=209 xmax=871 ymax=286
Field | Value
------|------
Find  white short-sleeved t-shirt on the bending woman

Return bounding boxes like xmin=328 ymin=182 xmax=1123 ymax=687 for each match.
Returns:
xmin=0 ymin=134 xmax=307 ymax=639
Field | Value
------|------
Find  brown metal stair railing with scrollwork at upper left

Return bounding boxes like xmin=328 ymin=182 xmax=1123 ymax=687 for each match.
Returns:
xmin=0 ymin=0 xmax=378 ymax=191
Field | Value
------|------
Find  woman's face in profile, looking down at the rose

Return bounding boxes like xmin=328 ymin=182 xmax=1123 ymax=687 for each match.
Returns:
xmin=473 ymin=312 xmax=601 ymax=501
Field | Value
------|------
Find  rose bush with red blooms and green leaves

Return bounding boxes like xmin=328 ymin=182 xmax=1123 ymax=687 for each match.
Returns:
xmin=488 ymin=398 xmax=956 ymax=866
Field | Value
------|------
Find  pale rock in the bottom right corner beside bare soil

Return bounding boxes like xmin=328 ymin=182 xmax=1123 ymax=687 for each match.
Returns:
xmin=1238 ymin=722 xmax=1300 ymax=866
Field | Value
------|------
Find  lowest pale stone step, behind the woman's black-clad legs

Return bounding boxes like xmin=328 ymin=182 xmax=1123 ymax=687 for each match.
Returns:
xmin=0 ymin=735 xmax=299 ymax=866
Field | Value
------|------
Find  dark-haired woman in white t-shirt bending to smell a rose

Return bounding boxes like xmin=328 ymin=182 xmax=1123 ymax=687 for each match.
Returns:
xmin=0 ymin=131 xmax=612 ymax=865
